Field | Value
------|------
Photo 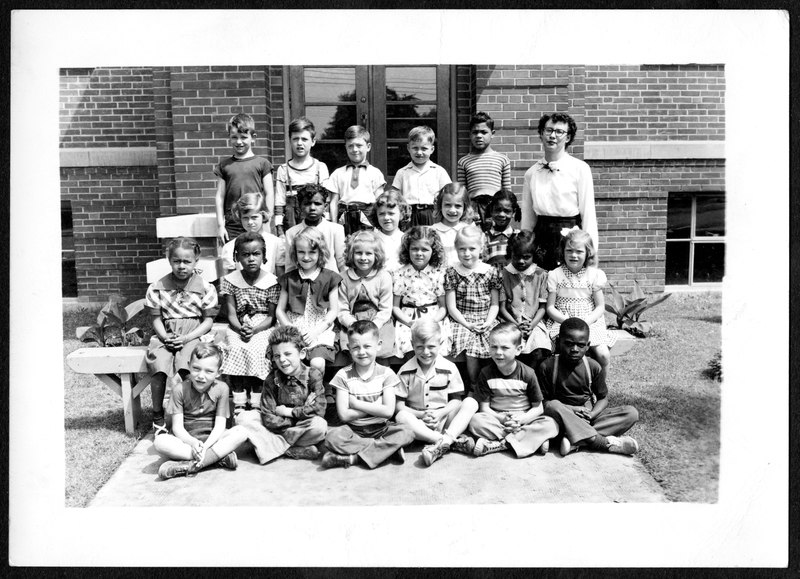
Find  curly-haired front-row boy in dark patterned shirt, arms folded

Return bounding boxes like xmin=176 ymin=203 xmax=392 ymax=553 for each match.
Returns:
xmin=259 ymin=326 xmax=328 ymax=462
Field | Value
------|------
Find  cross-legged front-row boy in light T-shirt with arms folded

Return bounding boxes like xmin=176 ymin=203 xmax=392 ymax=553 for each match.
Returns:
xmin=322 ymin=320 xmax=414 ymax=468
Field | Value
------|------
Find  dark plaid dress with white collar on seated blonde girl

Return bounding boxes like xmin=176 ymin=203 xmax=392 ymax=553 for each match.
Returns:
xmin=444 ymin=262 xmax=503 ymax=358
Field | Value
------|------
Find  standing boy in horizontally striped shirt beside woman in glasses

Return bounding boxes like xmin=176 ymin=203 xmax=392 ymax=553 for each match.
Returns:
xmin=456 ymin=112 xmax=511 ymax=231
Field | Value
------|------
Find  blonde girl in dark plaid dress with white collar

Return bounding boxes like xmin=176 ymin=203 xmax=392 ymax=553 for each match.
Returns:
xmin=444 ymin=225 xmax=503 ymax=391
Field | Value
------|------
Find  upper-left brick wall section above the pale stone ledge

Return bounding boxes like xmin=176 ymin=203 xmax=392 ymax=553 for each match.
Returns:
xmin=59 ymin=68 xmax=155 ymax=148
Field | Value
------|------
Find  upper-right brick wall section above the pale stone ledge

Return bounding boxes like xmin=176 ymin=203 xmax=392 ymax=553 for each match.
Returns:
xmin=579 ymin=64 xmax=725 ymax=141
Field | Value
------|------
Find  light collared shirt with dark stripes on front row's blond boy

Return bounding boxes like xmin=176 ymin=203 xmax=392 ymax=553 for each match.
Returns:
xmin=394 ymin=356 xmax=464 ymax=410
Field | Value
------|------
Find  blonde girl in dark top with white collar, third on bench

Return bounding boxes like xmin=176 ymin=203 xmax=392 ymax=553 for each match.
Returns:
xmin=277 ymin=227 xmax=342 ymax=380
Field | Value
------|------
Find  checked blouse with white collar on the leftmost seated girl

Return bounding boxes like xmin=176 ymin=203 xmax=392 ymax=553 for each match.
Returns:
xmin=144 ymin=273 xmax=219 ymax=320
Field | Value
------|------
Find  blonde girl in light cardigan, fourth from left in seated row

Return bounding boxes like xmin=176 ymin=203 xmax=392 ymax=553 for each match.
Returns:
xmin=339 ymin=230 xmax=394 ymax=358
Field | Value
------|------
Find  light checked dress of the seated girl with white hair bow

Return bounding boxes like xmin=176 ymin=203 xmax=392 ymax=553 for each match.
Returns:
xmin=547 ymin=265 xmax=617 ymax=348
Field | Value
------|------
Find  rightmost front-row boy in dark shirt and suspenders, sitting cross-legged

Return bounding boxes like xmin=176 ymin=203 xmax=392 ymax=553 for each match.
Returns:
xmin=536 ymin=318 xmax=639 ymax=456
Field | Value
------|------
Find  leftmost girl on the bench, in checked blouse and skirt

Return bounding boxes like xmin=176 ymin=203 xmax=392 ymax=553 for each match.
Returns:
xmin=144 ymin=237 xmax=219 ymax=435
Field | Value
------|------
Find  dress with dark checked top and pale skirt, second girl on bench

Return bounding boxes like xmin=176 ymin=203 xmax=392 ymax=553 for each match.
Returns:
xmin=219 ymin=269 xmax=281 ymax=380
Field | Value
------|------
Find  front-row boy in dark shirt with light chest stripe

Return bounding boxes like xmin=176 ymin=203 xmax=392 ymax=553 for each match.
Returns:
xmin=469 ymin=322 xmax=558 ymax=458
